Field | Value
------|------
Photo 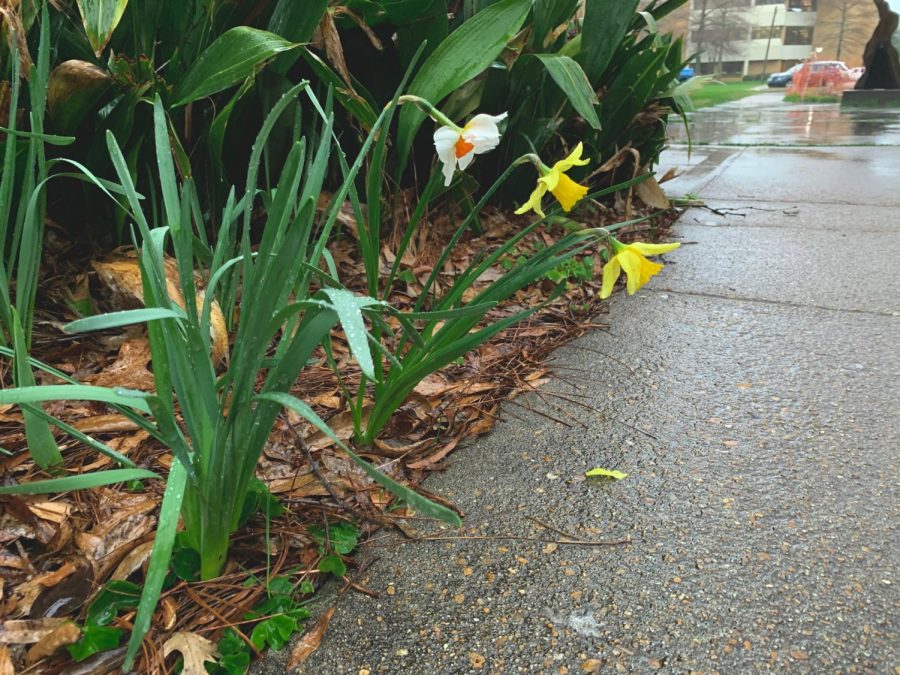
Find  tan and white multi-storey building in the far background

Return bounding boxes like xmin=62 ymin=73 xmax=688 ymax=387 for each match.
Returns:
xmin=660 ymin=0 xmax=878 ymax=77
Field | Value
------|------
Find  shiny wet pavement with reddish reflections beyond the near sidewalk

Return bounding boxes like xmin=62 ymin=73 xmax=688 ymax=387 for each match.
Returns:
xmin=669 ymin=89 xmax=900 ymax=145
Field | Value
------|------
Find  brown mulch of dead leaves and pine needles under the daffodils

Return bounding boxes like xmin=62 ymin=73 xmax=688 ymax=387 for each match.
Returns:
xmin=0 ymin=198 xmax=677 ymax=673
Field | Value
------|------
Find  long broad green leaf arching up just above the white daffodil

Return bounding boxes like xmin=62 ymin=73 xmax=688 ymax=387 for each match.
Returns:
xmin=396 ymin=0 xmax=533 ymax=171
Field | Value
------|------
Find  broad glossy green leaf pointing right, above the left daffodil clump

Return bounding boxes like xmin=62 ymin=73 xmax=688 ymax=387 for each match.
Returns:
xmin=173 ymin=26 xmax=298 ymax=106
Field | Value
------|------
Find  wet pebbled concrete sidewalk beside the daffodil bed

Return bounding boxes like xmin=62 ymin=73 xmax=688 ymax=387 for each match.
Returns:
xmin=254 ymin=93 xmax=900 ymax=675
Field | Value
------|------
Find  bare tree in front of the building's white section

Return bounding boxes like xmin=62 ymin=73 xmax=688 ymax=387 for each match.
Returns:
xmin=691 ymin=0 xmax=750 ymax=75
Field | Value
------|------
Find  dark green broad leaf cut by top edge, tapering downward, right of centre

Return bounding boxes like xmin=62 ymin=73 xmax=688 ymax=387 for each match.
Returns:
xmin=579 ymin=0 xmax=638 ymax=83
